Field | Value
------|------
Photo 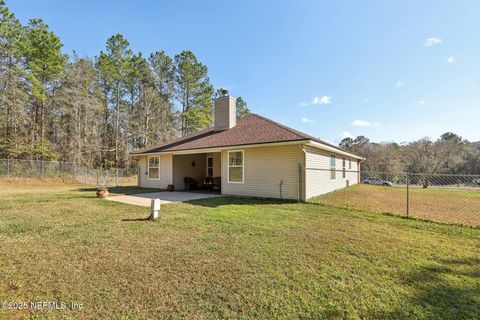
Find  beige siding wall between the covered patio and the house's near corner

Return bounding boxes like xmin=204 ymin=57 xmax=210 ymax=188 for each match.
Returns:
xmin=222 ymin=145 xmax=304 ymax=199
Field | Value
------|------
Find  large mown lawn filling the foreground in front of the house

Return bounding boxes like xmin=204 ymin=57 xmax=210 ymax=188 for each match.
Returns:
xmin=0 ymin=184 xmax=480 ymax=319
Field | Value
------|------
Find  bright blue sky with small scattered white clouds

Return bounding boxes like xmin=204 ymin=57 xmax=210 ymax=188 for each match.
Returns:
xmin=7 ymin=0 xmax=480 ymax=143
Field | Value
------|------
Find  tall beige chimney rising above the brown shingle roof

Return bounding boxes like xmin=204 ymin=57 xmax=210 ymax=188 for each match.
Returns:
xmin=213 ymin=90 xmax=237 ymax=131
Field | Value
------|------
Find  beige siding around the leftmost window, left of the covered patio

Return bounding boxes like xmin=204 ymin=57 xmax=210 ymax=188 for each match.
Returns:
xmin=138 ymin=154 xmax=172 ymax=189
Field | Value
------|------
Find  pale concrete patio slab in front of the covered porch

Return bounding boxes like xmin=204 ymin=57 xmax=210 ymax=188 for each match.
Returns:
xmin=107 ymin=191 xmax=221 ymax=207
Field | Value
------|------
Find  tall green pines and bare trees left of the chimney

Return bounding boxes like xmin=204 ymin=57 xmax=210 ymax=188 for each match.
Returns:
xmin=0 ymin=1 xmax=249 ymax=167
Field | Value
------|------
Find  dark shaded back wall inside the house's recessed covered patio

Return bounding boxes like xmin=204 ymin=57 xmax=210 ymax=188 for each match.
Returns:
xmin=172 ymin=153 xmax=207 ymax=190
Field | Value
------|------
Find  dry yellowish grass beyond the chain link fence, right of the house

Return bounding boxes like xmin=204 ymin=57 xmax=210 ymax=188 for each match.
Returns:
xmin=309 ymin=184 xmax=480 ymax=227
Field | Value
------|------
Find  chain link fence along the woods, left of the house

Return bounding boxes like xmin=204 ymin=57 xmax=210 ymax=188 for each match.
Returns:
xmin=0 ymin=159 xmax=138 ymax=187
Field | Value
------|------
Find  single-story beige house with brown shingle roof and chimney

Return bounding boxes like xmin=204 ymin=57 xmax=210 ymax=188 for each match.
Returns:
xmin=132 ymin=94 xmax=364 ymax=200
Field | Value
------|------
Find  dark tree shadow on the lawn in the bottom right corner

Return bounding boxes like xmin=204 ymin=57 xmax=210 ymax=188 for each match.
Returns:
xmin=372 ymin=258 xmax=480 ymax=319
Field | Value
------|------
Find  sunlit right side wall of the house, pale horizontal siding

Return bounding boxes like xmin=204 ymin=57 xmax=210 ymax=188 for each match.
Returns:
xmin=305 ymin=147 xmax=358 ymax=199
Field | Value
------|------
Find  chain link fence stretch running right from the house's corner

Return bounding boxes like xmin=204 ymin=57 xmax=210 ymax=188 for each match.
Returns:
xmin=311 ymin=171 xmax=480 ymax=227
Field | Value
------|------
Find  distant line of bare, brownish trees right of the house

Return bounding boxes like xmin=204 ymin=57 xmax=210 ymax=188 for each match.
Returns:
xmin=339 ymin=132 xmax=480 ymax=175
